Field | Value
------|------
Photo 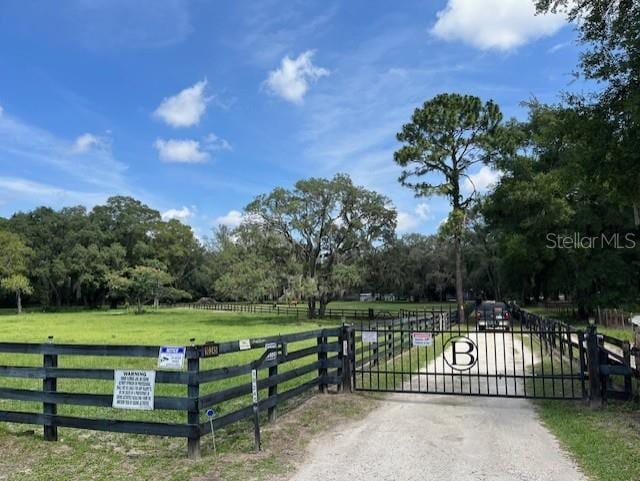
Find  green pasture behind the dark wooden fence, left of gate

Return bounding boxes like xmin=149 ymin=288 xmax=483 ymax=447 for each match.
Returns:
xmin=0 ymin=309 xmax=335 ymax=432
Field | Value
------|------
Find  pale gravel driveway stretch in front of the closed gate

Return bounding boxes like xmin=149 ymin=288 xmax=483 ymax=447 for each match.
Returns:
xmin=290 ymin=330 xmax=586 ymax=481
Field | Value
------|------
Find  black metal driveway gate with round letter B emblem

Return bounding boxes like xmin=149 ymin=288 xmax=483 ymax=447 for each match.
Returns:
xmin=352 ymin=311 xmax=587 ymax=399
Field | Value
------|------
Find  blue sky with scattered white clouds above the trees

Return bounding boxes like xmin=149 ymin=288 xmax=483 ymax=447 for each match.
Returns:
xmin=0 ymin=0 xmax=585 ymax=236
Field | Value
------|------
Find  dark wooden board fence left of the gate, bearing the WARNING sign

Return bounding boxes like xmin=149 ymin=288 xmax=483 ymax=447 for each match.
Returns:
xmin=0 ymin=326 xmax=350 ymax=457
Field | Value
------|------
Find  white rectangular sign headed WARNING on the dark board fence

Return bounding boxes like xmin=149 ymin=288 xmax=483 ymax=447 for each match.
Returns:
xmin=112 ymin=371 xmax=156 ymax=411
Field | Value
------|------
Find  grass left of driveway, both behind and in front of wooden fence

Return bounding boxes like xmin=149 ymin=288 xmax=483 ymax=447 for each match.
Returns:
xmin=0 ymin=309 xmax=364 ymax=481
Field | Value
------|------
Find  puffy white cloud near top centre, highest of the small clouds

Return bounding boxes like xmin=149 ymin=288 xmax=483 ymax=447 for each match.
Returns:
xmin=264 ymin=50 xmax=329 ymax=104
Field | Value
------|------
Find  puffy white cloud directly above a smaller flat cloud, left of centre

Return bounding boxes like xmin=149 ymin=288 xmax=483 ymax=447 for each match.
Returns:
xmin=153 ymin=79 xmax=211 ymax=127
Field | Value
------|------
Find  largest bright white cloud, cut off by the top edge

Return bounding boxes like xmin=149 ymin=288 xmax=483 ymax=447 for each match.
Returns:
xmin=431 ymin=0 xmax=566 ymax=50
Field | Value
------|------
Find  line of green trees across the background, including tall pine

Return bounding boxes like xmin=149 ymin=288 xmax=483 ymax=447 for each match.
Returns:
xmin=0 ymin=0 xmax=640 ymax=316
